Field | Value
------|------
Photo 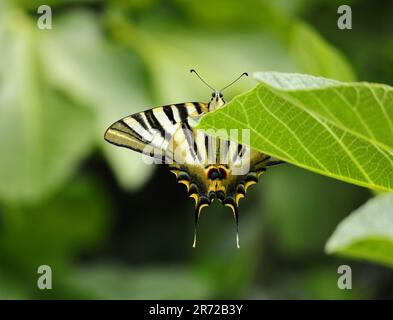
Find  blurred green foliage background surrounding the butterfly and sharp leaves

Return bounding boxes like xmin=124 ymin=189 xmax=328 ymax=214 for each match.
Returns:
xmin=0 ymin=0 xmax=393 ymax=299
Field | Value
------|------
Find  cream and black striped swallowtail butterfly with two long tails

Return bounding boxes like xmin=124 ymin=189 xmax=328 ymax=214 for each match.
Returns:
xmin=104 ymin=69 xmax=283 ymax=248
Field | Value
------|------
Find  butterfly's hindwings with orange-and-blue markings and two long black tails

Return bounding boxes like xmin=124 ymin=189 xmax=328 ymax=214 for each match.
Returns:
xmin=170 ymin=136 xmax=275 ymax=247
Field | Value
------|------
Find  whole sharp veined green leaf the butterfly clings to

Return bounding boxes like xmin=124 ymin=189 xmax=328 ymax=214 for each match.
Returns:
xmin=199 ymin=72 xmax=393 ymax=191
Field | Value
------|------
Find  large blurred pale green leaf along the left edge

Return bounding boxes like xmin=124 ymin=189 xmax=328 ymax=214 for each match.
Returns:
xmin=0 ymin=10 xmax=94 ymax=202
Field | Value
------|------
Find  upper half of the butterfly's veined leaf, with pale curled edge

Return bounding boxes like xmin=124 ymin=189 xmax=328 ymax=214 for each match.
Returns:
xmin=255 ymin=72 xmax=393 ymax=152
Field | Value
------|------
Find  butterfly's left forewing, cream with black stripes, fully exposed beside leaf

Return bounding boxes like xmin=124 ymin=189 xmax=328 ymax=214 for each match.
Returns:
xmin=104 ymin=102 xmax=208 ymax=163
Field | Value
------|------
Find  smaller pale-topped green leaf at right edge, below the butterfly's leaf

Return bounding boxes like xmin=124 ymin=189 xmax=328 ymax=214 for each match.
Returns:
xmin=326 ymin=193 xmax=393 ymax=268
